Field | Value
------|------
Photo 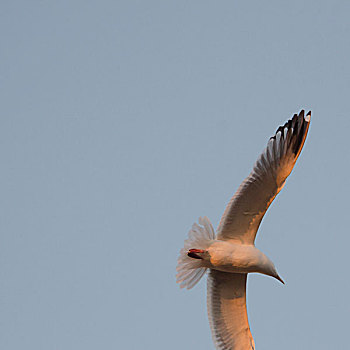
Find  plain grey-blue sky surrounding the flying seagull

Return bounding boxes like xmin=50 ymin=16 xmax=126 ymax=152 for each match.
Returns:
xmin=0 ymin=0 xmax=350 ymax=350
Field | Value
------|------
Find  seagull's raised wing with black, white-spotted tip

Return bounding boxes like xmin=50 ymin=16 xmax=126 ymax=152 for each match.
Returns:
xmin=217 ymin=110 xmax=311 ymax=244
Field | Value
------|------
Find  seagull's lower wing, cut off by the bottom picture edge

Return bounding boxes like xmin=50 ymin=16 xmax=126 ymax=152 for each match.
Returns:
xmin=207 ymin=270 xmax=255 ymax=350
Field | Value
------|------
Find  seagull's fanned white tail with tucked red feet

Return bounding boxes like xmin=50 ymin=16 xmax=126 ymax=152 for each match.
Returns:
xmin=176 ymin=216 xmax=215 ymax=289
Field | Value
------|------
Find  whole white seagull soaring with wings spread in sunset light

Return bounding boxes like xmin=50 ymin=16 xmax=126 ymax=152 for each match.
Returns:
xmin=176 ymin=110 xmax=311 ymax=350
